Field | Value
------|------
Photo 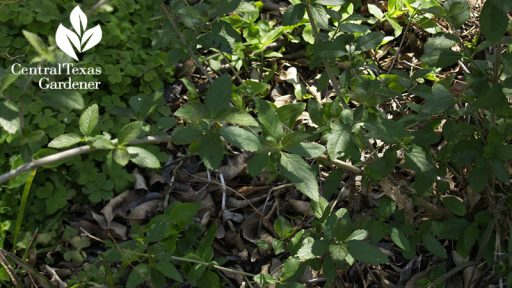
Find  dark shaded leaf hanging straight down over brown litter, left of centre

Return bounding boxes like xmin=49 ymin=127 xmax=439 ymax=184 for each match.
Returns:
xmin=198 ymin=132 xmax=224 ymax=170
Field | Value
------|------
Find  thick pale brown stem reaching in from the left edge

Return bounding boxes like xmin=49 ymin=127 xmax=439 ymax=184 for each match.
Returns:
xmin=0 ymin=136 xmax=171 ymax=184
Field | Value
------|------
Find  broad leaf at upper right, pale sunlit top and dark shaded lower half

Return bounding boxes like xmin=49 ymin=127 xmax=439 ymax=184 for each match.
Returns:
xmin=421 ymin=36 xmax=461 ymax=67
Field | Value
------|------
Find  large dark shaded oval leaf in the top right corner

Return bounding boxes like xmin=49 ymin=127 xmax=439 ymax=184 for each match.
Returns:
xmin=480 ymin=0 xmax=508 ymax=44
